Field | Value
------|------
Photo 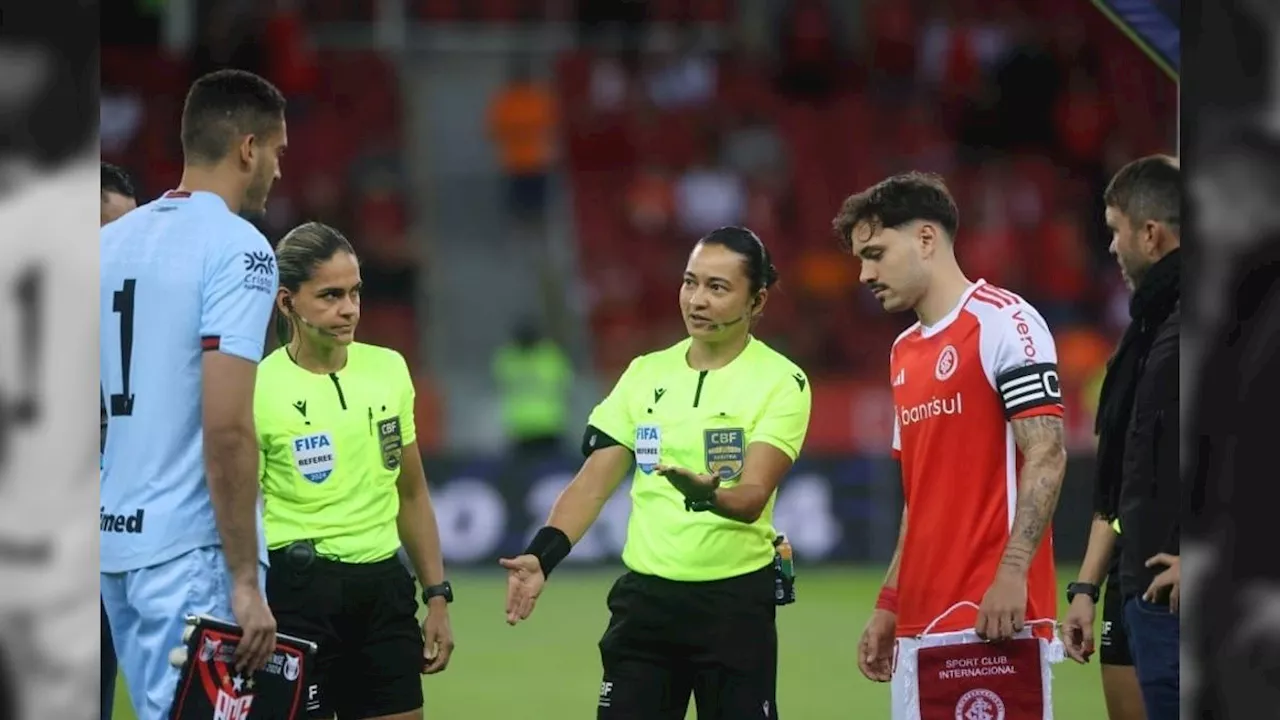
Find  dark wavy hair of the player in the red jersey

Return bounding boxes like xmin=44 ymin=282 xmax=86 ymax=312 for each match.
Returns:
xmin=831 ymin=172 xmax=960 ymax=250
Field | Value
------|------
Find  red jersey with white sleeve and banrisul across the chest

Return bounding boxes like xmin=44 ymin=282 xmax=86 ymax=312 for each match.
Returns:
xmin=890 ymin=281 xmax=1062 ymax=637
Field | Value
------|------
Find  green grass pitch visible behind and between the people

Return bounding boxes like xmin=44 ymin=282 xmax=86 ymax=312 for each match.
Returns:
xmin=115 ymin=566 xmax=1106 ymax=720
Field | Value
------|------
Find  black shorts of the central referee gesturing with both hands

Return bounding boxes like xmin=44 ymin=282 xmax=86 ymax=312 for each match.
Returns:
xmin=596 ymin=565 xmax=778 ymax=720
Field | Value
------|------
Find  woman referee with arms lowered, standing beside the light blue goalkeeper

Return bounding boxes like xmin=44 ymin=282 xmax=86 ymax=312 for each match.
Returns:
xmin=253 ymin=223 xmax=453 ymax=720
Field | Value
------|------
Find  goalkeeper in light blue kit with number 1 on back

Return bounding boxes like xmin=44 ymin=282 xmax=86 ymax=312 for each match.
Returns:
xmin=100 ymin=70 xmax=287 ymax=720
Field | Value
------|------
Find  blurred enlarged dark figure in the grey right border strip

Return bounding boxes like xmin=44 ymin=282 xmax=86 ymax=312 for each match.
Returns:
xmin=1183 ymin=124 xmax=1280 ymax=719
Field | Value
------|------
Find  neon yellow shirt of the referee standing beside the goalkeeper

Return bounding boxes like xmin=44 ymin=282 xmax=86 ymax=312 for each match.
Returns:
xmin=253 ymin=342 xmax=416 ymax=562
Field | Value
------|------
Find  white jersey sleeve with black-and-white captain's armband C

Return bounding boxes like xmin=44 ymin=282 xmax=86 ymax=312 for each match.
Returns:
xmin=982 ymin=302 xmax=1062 ymax=420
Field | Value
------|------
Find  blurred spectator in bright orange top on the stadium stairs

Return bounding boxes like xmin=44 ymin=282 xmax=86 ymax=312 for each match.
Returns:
xmin=489 ymin=56 xmax=557 ymax=229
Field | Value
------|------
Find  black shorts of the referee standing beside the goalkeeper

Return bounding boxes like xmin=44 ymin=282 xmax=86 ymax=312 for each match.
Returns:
xmin=266 ymin=550 xmax=424 ymax=719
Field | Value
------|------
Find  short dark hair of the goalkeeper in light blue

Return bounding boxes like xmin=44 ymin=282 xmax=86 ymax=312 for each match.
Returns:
xmin=182 ymin=69 xmax=285 ymax=164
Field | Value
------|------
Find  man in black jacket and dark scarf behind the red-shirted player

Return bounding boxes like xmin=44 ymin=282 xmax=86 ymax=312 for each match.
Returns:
xmin=1065 ymin=155 xmax=1181 ymax=720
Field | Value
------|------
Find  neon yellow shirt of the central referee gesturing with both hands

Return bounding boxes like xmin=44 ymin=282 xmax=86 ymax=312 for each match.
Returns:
xmin=586 ymin=338 xmax=812 ymax=580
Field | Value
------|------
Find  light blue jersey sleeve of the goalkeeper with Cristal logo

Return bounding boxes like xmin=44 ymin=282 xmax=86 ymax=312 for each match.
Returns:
xmin=200 ymin=229 xmax=279 ymax=363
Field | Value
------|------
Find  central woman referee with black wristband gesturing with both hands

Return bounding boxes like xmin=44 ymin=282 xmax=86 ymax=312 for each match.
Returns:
xmin=500 ymin=222 xmax=810 ymax=720
